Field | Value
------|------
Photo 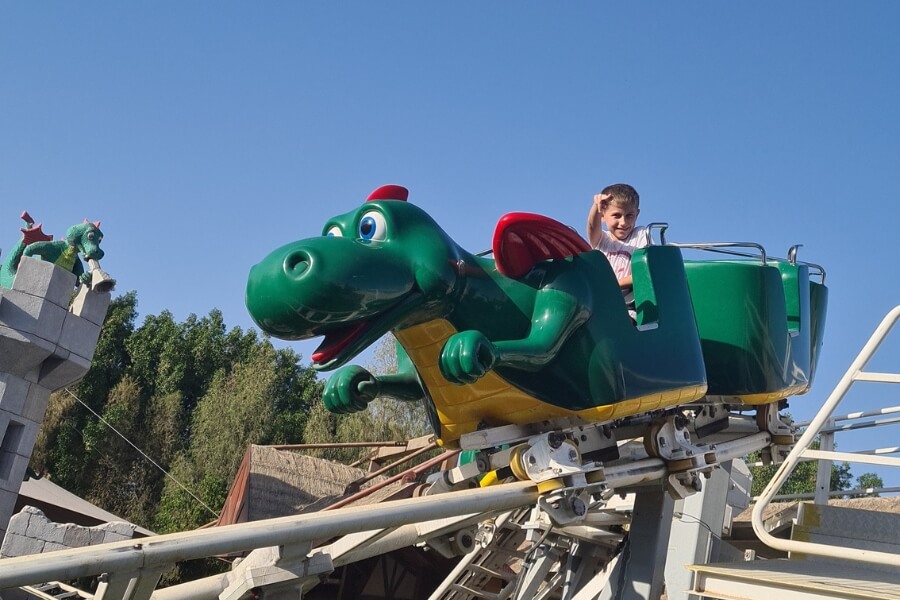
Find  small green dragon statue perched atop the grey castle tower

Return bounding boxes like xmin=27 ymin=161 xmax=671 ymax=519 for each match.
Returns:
xmin=0 ymin=212 xmax=103 ymax=288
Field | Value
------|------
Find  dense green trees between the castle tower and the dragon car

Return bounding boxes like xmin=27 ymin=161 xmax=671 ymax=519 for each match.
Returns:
xmin=31 ymin=292 xmax=321 ymax=532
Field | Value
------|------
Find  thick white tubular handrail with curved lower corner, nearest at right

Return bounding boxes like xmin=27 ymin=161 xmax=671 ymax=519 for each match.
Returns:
xmin=752 ymin=306 xmax=900 ymax=567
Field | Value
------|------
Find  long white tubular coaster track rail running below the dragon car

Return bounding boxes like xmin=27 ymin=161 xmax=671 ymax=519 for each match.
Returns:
xmin=0 ymin=424 xmax=771 ymax=600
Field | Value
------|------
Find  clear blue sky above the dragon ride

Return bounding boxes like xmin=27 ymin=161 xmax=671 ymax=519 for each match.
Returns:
xmin=0 ymin=1 xmax=900 ymax=482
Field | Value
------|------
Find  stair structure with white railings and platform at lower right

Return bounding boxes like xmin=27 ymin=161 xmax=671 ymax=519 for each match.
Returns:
xmin=690 ymin=306 xmax=900 ymax=600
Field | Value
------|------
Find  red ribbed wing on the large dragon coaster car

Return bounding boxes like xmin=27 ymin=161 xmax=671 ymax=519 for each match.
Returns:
xmin=493 ymin=213 xmax=591 ymax=278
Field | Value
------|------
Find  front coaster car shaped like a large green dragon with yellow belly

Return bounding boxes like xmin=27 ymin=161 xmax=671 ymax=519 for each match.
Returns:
xmin=246 ymin=185 xmax=706 ymax=446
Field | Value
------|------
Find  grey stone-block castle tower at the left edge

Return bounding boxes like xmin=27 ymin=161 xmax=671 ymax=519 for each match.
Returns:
xmin=0 ymin=257 xmax=110 ymax=538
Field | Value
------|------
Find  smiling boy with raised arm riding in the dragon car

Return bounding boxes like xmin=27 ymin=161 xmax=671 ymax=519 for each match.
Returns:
xmin=587 ymin=183 xmax=650 ymax=318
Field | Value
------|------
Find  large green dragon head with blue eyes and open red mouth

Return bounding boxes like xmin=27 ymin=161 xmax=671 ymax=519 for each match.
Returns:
xmin=246 ymin=185 xmax=460 ymax=369
